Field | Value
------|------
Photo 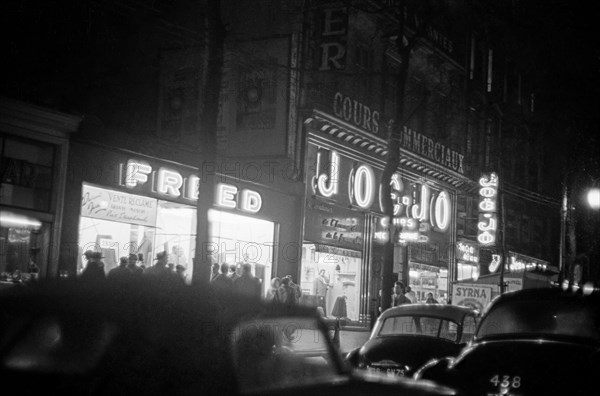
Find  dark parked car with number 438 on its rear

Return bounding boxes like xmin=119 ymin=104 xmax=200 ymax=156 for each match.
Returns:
xmin=415 ymin=288 xmax=600 ymax=396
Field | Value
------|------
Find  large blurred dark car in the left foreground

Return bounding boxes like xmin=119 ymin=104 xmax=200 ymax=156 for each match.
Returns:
xmin=0 ymin=280 xmax=455 ymax=396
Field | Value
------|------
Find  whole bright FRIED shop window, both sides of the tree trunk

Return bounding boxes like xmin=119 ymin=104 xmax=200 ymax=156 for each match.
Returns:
xmin=78 ymin=183 xmax=275 ymax=293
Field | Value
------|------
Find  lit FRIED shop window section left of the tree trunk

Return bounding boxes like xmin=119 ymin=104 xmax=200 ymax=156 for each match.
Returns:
xmin=78 ymin=184 xmax=196 ymax=282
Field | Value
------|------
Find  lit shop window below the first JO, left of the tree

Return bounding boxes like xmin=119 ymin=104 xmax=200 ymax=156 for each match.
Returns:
xmin=300 ymin=243 xmax=362 ymax=321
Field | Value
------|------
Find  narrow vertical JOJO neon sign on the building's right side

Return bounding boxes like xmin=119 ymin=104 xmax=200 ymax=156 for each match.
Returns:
xmin=477 ymin=172 xmax=498 ymax=246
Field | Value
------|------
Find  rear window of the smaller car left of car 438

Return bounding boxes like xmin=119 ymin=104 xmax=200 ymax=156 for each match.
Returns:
xmin=378 ymin=315 xmax=458 ymax=341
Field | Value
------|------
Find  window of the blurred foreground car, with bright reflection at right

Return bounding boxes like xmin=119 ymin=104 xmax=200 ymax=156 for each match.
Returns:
xmin=231 ymin=317 xmax=338 ymax=393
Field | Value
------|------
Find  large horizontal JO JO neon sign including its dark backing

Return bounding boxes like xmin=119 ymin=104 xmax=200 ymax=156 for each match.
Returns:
xmin=311 ymin=150 xmax=452 ymax=242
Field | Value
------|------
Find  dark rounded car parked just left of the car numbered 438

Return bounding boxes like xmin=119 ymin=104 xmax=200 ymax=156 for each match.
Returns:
xmin=346 ymin=304 xmax=478 ymax=376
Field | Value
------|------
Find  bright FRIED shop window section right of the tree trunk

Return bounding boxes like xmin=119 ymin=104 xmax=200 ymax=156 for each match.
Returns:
xmin=208 ymin=209 xmax=275 ymax=295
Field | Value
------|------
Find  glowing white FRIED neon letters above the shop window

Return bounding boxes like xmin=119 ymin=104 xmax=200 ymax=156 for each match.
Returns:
xmin=119 ymin=159 xmax=262 ymax=213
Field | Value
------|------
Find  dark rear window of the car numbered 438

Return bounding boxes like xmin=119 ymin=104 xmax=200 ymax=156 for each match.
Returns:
xmin=477 ymin=300 xmax=600 ymax=341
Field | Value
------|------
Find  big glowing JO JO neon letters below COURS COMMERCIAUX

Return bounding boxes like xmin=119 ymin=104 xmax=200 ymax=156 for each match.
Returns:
xmin=312 ymin=150 xmax=452 ymax=232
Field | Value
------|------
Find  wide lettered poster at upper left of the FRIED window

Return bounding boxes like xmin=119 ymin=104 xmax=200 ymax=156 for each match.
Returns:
xmin=81 ymin=184 xmax=157 ymax=227
